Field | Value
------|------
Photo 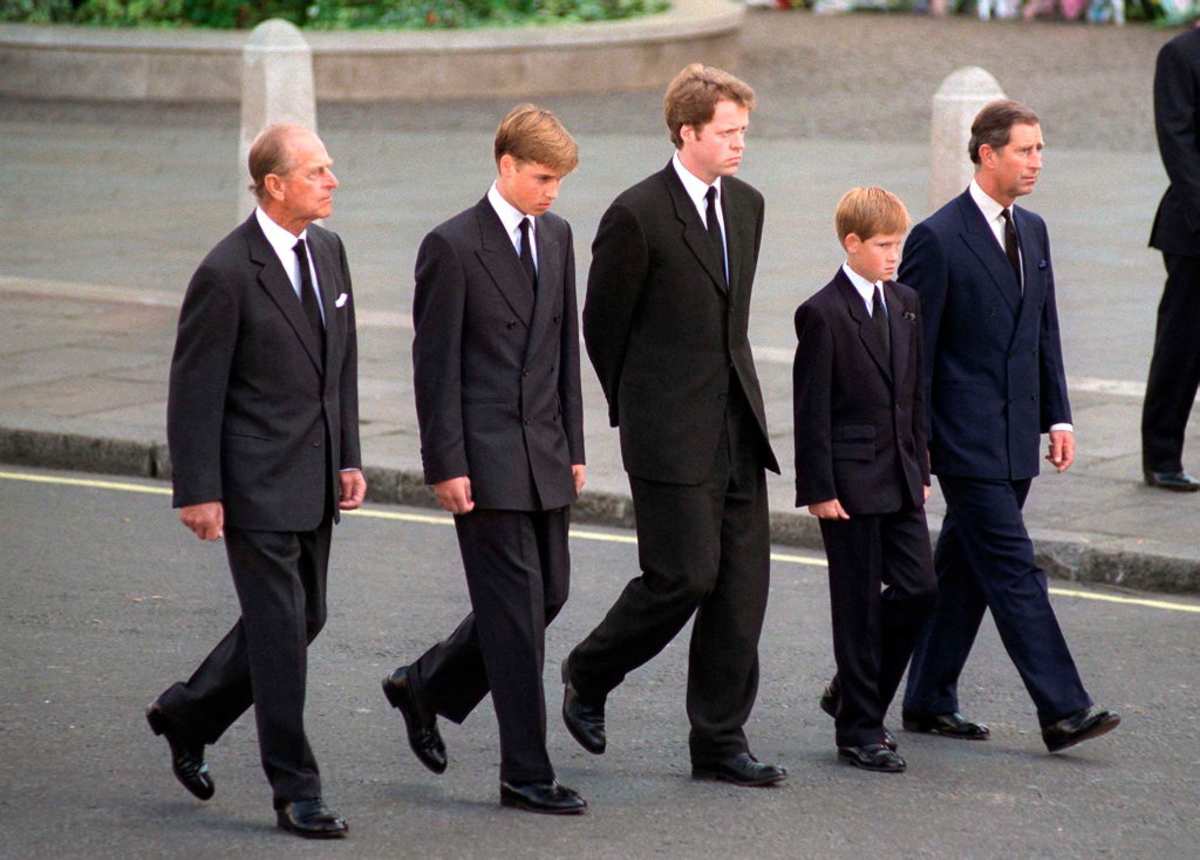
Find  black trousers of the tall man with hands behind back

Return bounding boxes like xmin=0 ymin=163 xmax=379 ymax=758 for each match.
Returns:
xmin=568 ymin=380 xmax=770 ymax=765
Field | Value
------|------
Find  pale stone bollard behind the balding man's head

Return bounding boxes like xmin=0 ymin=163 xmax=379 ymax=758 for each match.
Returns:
xmin=238 ymin=18 xmax=317 ymax=223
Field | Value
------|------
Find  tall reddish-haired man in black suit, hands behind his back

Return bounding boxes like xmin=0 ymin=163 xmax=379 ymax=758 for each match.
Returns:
xmin=563 ymin=64 xmax=786 ymax=786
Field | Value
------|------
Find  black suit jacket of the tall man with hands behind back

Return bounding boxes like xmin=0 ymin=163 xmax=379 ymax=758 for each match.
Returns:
xmin=583 ymin=163 xmax=779 ymax=483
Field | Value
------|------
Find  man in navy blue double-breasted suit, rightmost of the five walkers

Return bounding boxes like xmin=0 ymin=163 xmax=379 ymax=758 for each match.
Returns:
xmin=900 ymin=100 xmax=1120 ymax=752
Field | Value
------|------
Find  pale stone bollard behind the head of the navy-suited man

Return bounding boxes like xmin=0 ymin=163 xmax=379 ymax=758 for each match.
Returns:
xmin=929 ymin=66 xmax=1004 ymax=212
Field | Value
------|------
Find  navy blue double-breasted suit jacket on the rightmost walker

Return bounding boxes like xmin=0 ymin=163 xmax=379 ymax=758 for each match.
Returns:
xmin=900 ymin=192 xmax=1070 ymax=480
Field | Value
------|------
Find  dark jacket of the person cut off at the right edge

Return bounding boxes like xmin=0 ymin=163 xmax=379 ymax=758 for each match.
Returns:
xmin=1150 ymin=30 xmax=1200 ymax=257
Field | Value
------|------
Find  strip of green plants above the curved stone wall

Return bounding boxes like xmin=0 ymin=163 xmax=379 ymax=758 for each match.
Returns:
xmin=0 ymin=0 xmax=670 ymax=30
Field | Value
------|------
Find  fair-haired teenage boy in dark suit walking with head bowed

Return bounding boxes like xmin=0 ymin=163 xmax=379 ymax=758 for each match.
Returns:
xmin=383 ymin=104 xmax=587 ymax=814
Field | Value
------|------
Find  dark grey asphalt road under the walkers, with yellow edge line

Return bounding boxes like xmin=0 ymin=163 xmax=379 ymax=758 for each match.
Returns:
xmin=0 ymin=467 xmax=1200 ymax=860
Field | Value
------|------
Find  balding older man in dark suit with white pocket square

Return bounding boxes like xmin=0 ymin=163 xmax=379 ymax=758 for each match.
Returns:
xmin=146 ymin=125 xmax=366 ymax=838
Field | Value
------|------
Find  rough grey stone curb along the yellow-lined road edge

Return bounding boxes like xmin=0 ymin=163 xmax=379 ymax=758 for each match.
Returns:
xmin=0 ymin=427 xmax=1200 ymax=594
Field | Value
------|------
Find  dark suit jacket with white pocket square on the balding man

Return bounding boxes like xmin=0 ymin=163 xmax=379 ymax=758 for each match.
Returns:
xmin=167 ymin=215 xmax=361 ymax=531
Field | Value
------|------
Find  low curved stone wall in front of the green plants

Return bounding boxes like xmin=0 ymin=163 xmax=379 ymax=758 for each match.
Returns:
xmin=0 ymin=0 xmax=745 ymax=102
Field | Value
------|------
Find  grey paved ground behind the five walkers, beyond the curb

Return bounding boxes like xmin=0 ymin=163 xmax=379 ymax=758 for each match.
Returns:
xmin=0 ymin=14 xmax=1200 ymax=591
